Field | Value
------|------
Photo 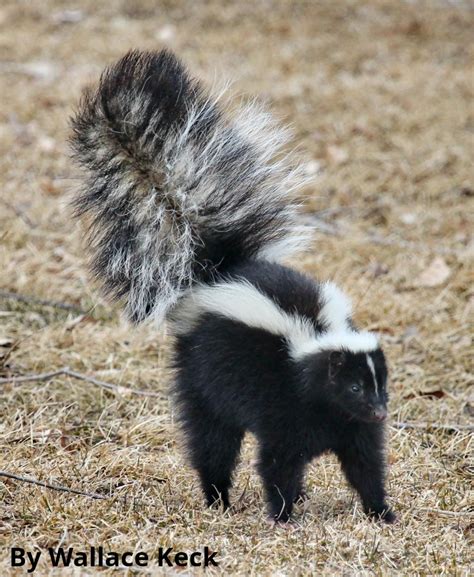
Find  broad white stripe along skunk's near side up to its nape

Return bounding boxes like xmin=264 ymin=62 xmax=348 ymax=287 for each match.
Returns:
xmin=172 ymin=280 xmax=378 ymax=359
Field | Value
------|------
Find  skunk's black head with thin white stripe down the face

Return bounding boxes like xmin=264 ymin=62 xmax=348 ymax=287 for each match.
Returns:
xmin=310 ymin=348 xmax=388 ymax=422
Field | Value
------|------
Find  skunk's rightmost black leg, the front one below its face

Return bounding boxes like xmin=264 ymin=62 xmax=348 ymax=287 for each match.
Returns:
xmin=336 ymin=424 xmax=396 ymax=523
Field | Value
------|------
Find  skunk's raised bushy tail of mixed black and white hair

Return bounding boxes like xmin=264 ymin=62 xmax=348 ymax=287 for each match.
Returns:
xmin=72 ymin=51 xmax=305 ymax=322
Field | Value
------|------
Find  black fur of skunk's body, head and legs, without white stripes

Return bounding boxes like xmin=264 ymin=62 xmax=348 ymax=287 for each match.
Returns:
xmin=174 ymin=262 xmax=395 ymax=523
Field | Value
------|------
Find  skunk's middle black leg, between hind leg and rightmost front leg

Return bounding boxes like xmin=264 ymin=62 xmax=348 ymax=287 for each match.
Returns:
xmin=258 ymin=446 xmax=304 ymax=523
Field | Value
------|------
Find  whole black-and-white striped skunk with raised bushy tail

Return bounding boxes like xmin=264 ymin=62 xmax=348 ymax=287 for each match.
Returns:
xmin=71 ymin=51 xmax=395 ymax=523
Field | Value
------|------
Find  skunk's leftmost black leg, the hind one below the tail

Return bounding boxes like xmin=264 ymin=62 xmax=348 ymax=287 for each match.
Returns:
xmin=181 ymin=402 xmax=244 ymax=509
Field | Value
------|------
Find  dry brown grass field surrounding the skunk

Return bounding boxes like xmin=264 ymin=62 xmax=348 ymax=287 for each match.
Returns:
xmin=0 ymin=0 xmax=474 ymax=577
